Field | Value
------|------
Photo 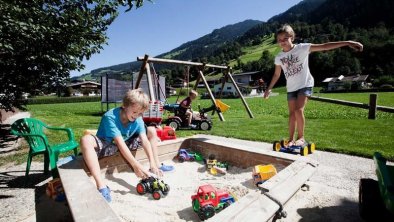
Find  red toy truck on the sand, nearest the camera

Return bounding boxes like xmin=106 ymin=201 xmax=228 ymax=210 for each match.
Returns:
xmin=192 ymin=184 xmax=235 ymax=220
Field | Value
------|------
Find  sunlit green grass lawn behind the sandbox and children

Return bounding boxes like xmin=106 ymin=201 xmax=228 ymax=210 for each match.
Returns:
xmin=0 ymin=88 xmax=394 ymax=164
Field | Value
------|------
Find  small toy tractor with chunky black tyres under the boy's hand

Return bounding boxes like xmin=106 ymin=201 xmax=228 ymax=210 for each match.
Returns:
xmin=136 ymin=176 xmax=170 ymax=200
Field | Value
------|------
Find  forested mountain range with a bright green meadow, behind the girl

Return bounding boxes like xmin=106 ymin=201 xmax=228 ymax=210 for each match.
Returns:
xmin=76 ymin=0 xmax=394 ymax=87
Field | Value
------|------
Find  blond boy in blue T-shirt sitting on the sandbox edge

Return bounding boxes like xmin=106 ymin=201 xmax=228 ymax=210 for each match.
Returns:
xmin=80 ymin=89 xmax=172 ymax=202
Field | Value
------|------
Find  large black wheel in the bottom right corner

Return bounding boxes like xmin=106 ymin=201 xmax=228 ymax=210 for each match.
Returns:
xmin=358 ymin=179 xmax=386 ymax=221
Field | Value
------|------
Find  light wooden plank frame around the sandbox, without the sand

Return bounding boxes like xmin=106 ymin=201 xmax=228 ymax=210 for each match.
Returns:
xmin=58 ymin=135 xmax=318 ymax=222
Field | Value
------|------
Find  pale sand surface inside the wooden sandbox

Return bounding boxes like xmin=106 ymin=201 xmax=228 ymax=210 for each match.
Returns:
xmin=106 ymin=161 xmax=257 ymax=222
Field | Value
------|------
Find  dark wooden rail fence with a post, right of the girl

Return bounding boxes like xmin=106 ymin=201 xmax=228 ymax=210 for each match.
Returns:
xmin=310 ymin=93 xmax=394 ymax=119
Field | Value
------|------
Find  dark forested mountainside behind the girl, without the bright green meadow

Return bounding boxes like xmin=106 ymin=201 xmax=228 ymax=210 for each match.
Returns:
xmin=208 ymin=0 xmax=394 ymax=86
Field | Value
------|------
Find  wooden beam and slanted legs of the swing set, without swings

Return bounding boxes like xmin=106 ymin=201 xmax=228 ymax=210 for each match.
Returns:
xmin=135 ymin=55 xmax=254 ymax=121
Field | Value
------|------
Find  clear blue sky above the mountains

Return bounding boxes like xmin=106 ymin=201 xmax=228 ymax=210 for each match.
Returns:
xmin=71 ymin=0 xmax=301 ymax=77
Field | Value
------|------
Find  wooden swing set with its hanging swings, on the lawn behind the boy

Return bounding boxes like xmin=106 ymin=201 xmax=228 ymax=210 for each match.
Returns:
xmin=135 ymin=55 xmax=254 ymax=126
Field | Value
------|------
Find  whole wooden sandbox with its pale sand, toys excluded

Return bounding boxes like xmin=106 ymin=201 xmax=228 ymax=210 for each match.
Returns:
xmin=59 ymin=135 xmax=318 ymax=221
